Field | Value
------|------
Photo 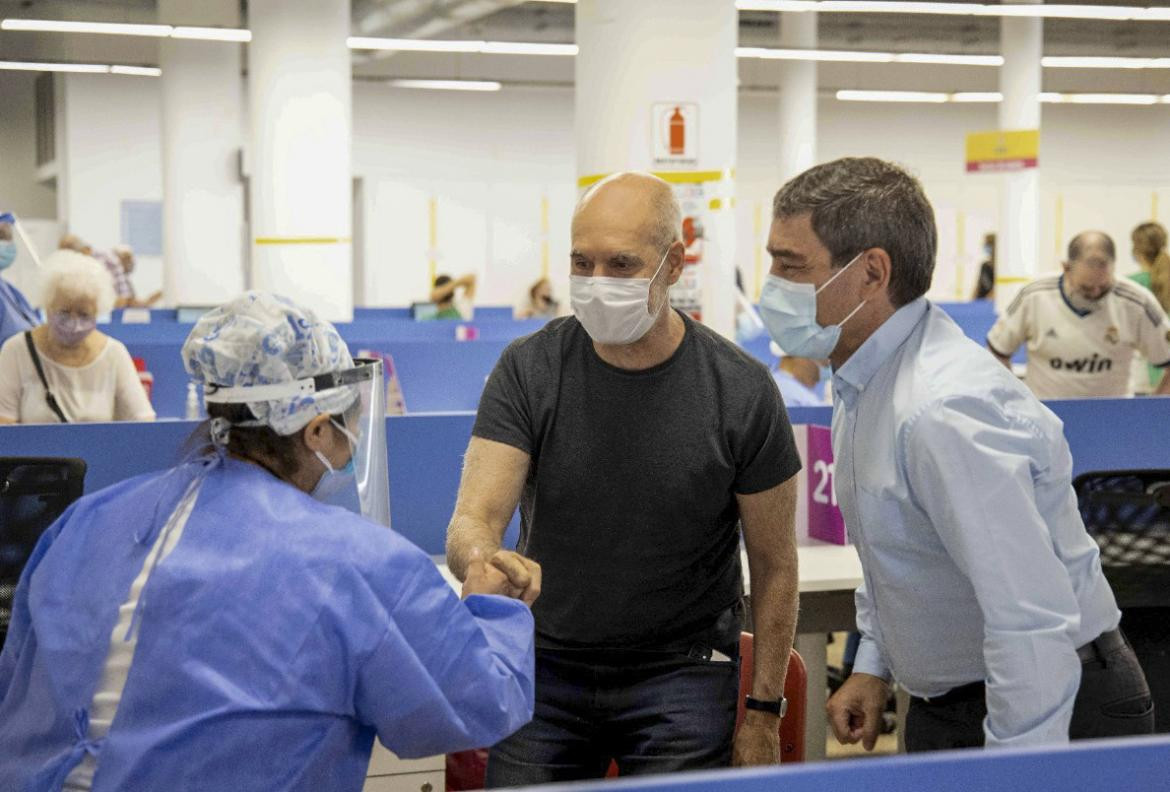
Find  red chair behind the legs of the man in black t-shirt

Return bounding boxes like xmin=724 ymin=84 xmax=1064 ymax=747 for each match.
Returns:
xmin=447 ymin=633 xmax=808 ymax=792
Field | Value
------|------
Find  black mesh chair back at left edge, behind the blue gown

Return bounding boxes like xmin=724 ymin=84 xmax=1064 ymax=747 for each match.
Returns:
xmin=0 ymin=456 xmax=85 ymax=647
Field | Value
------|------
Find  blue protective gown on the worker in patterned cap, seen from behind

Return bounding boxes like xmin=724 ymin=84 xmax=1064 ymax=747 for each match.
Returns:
xmin=0 ymin=459 xmax=534 ymax=792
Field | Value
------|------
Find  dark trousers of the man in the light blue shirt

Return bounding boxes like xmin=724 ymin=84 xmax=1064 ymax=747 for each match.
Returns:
xmin=906 ymin=631 xmax=1154 ymax=752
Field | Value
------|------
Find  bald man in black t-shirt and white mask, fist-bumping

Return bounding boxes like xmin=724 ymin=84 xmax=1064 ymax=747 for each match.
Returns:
xmin=447 ymin=173 xmax=800 ymax=787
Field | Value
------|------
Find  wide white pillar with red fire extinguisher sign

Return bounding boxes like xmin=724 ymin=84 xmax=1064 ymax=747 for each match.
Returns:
xmin=576 ymin=0 xmax=738 ymax=338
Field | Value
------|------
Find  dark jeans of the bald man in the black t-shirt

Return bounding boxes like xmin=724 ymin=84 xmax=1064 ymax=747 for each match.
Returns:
xmin=487 ymin=608 xmax=739 ymax=788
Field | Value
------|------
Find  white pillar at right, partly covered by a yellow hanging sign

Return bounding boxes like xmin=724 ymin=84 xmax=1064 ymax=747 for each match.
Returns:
xmin=996 ymin=6 xmax=1044 ymax=311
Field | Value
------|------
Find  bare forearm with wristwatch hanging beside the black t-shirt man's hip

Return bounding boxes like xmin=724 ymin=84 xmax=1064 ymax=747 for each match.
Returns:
xmin=751 ymin=549 xmax=800 ymax=700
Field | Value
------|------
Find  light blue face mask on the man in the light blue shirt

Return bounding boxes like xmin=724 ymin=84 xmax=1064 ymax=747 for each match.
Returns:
xmin=759 ymin=253 xmax=866 ymax=359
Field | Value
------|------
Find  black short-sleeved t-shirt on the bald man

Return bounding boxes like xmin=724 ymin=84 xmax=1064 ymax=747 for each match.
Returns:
xmin=473 ymin=315 xmax=800 ymax=648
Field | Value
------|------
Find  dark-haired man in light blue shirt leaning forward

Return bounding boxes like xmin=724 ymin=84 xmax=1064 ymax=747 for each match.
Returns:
xmin=761 ymin=158 xmax=1152 ymax=751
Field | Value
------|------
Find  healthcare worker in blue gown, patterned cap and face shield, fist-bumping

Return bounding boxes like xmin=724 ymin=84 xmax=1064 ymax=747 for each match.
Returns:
xmin=0 ymin=292 xmax=534 ymax=792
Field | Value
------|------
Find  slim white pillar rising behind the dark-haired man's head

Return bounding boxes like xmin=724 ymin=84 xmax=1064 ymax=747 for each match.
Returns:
xmin=777 ymin=12 xmax=817 ymax=185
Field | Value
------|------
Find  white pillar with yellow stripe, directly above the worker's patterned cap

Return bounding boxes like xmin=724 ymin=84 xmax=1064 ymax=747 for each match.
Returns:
xmin=248 ymin=0 xmax=353 ymax=322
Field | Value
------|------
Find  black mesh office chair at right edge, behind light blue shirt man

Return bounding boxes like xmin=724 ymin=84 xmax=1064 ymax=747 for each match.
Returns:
xmin=1073 ymin=470 xmax=1170 ymax=734
